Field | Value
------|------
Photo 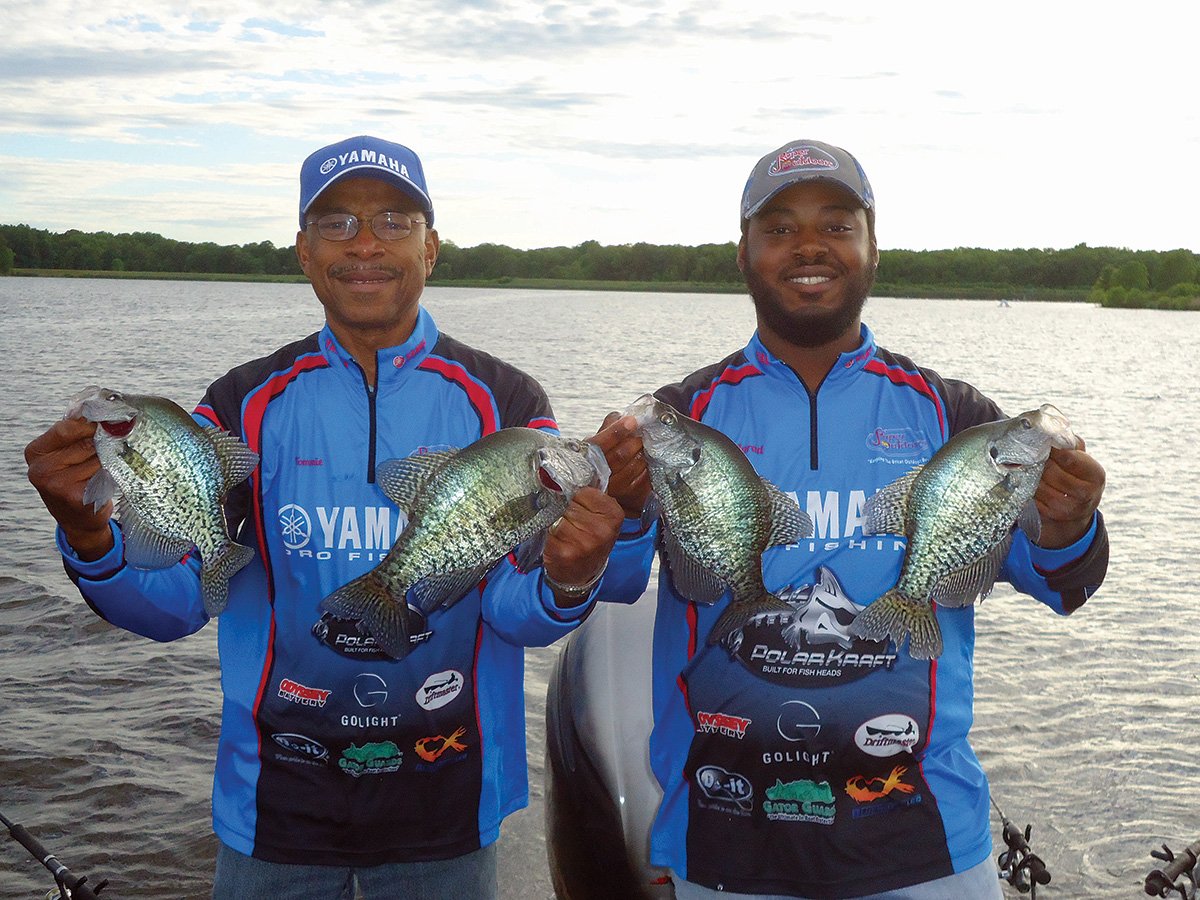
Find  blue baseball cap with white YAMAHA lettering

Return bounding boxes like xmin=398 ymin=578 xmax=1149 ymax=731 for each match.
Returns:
xmin=300 ymin=134 xmax=433 ymax=230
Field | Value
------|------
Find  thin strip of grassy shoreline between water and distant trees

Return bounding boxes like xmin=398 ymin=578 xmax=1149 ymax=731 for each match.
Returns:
xmin=4 ymin=269 xmax=1088 ymax=302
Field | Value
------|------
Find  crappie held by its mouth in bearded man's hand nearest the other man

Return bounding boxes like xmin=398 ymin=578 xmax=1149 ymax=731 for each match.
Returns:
xmin=625 ymin=394 xmax=812 ymax=647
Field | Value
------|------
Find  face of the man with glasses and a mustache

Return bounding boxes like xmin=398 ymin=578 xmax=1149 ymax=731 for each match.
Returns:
xmin=296 ymin=178 xmax=438 ymax=349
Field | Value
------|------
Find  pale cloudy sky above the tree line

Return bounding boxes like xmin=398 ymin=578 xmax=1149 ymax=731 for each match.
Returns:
xmin=0 ymin=0 xmax=1200 ymax=252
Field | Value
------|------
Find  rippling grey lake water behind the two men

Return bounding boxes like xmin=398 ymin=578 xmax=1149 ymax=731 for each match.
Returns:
xmin=0 ymin=278 xmax=1200 ymax=900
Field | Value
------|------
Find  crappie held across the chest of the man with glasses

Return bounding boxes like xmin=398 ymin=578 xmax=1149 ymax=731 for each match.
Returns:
xmin=320 ymin=427 xmax=608 ymax=659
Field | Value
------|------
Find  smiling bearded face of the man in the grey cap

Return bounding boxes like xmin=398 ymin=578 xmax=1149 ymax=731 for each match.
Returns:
xmin=738 ymin=181 xmax=880 ymax=348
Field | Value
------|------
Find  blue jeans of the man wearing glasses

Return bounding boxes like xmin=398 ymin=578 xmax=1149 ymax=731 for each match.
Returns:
xmin=212 ymin=844 xmax=497 ymax=900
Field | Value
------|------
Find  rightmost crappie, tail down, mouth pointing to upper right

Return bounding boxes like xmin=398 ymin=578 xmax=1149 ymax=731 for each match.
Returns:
xmin=850 ymin=403 xmax=1078 ymax=659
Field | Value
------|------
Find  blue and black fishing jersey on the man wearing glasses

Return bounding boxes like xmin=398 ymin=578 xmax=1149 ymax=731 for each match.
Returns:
xmin=60 ymin=310 xmax=604 ymax=865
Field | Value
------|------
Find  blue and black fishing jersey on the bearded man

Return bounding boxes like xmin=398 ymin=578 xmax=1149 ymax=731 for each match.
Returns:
xmin=610 ymin=326 xmax=1108 ymax=898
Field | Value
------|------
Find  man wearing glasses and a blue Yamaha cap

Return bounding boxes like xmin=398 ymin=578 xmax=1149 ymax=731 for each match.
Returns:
xmin=26 ymin=136 xmax=635 ymax=900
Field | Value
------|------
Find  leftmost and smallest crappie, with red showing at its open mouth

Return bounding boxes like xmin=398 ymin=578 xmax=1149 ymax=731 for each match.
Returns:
xmin=67 ymin=385 xmax=258 ymax=616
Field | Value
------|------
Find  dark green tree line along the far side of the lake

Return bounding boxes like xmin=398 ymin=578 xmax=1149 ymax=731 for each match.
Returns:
xmin=0 ymin=224 xmax=1200 ymax=306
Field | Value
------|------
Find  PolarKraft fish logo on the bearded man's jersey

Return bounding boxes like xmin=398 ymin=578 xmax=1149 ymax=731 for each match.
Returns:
xmin=737 ymin=566 xmax=896 ymax=688
